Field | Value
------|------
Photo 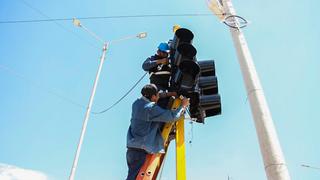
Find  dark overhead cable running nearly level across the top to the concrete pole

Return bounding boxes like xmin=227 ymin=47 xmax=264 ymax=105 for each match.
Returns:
xmin=0 ymin=13 xmax=212 ymax=24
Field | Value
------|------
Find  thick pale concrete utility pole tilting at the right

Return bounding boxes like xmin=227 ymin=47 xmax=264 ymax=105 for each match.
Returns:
xmin=208 ymin=0 xmax=290 ymax=180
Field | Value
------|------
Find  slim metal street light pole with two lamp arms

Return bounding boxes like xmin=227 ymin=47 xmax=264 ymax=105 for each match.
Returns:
xmin=69 ymin=19 xmax=147 ymax=180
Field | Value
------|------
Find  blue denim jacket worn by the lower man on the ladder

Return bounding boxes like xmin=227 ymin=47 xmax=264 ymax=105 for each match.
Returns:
xmin=127 ymin=97 xmax=183 ymax=154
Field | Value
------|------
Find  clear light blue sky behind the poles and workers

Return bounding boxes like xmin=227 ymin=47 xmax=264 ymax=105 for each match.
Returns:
xmin=0 ymin=0 xmax=320 ymax=180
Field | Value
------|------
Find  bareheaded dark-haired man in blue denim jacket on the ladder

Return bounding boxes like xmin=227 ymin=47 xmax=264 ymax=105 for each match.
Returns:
xmin=126 ymin=84 xmax=190 ymax=180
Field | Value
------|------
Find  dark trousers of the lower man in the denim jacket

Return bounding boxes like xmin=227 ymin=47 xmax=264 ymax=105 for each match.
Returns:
xmin=127 ymin=148 xmax=148 ymax=180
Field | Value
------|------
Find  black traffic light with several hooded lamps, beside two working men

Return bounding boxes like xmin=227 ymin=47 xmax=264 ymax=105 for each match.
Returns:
xmin=170 ymin=28 xmax=221 ymax=123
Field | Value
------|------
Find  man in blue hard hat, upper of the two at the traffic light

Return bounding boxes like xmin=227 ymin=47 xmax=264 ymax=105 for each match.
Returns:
xmin=142 ymin=43 xmax=177 ymax=108
